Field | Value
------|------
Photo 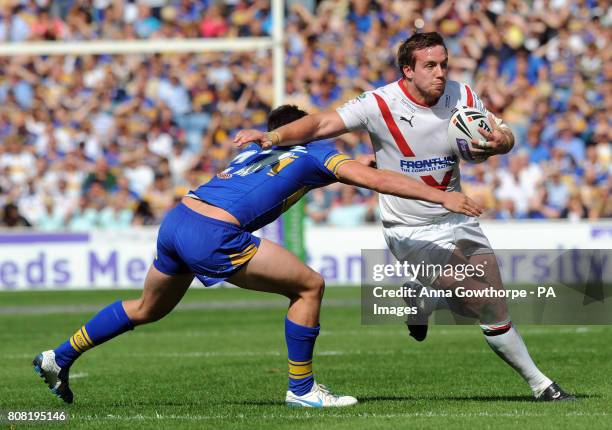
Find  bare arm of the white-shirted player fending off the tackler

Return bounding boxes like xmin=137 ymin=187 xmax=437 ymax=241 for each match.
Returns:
xmin=234 ymin=111 xmax=348 ymax=149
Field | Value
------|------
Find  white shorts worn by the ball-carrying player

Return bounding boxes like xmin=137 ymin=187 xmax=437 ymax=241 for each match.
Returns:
xmin=383 ymin=213 xmax=493 ymax=286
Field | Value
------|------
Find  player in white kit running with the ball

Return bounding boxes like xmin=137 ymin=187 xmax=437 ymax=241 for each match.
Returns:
xmin=234 ymin=32 xmax=575 ymax=401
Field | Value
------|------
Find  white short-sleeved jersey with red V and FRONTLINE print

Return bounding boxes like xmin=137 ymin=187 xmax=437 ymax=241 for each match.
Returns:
xmin=337 ymin=80 xmax=488 ymax=227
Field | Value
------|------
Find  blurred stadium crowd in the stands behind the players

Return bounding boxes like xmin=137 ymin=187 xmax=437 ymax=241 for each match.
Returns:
xmin=0 ymin=0 xmax=612 ymax=230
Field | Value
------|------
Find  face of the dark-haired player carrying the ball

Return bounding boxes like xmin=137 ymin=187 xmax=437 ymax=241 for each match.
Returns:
xmin=405 ymin=46 xmax=448 ymax=101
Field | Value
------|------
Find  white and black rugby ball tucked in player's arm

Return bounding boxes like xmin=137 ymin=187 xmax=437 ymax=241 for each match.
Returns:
xmin=448 ymin=106 xmax=491 ymax=163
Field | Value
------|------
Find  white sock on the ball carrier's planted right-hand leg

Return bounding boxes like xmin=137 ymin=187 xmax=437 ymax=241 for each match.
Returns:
xmin=480 ymin=321 xmax=552 ymax=397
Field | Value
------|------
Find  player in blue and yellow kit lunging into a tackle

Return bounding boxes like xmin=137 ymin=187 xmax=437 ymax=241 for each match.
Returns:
xmin=33 ymin=105 xmax=481 ymax=407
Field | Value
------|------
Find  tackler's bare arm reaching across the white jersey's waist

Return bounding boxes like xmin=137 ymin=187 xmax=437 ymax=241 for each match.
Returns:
xmin=336 ymin=161 xmax=482 ymax=216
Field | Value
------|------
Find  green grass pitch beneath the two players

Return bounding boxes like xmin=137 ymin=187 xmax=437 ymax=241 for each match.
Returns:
xmin=0 ymin=288 xmax=612 ymax=430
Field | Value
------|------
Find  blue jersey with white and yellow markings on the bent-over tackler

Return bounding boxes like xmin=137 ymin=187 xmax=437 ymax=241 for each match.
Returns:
xmin=189 ymin=141 xmax=351 ymax=231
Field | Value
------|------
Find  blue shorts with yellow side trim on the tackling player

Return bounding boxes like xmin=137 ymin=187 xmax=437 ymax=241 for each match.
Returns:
xmin=153 ymin=203 xmax=261 ymax=287
